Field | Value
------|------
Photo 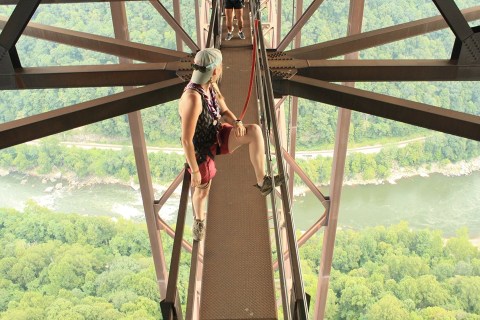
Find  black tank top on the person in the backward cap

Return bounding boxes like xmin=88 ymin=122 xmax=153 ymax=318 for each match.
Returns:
xmin=185 ymin=82 xmax=220 ymax=164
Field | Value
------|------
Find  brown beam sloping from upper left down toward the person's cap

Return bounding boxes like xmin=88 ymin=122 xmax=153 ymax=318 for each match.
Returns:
xmin=0 ymin=17 xmax=188 ymax=62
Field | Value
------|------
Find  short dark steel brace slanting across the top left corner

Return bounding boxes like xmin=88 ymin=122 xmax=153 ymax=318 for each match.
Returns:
xmin=0 ymin=0 xmax=40 ymax=72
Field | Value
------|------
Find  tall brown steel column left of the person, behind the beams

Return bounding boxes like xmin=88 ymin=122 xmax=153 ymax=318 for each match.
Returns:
xmin=110 ymin=2 xmax=168 ymax=298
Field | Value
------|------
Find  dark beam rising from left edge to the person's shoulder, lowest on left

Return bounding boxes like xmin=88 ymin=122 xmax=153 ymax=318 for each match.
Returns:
xmin=0 ymin=78 xmax=185 ymax=149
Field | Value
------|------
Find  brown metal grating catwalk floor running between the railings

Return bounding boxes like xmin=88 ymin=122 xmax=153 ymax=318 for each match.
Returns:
xmin=200 ymin=8 xmax=277 ymax=319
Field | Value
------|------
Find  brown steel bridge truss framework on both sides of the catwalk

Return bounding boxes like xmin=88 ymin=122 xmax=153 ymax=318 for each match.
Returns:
xmin=0 ymin=0 xmax=480 ymax=319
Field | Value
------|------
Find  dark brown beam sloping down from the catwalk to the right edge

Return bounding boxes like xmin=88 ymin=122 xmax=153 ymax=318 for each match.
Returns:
xmin=273 ymin=76 xmax=480 ymax=141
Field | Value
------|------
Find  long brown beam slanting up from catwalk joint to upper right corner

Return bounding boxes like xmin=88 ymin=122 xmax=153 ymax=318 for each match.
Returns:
xmin=285 ymin=6 xmax=480 ymax=59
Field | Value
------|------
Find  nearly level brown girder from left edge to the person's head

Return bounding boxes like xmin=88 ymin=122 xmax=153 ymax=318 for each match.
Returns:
xmin=0 ymin=63 xmax=182 ymax=90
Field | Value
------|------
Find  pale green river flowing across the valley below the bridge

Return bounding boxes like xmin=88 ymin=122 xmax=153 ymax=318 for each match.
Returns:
xmin=0 ymin=171 xmax=480 ymax=238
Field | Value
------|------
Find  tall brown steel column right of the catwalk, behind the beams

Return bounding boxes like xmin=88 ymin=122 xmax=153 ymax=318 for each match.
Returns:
xmin=315 ymin=0 xmax=365 ymax=319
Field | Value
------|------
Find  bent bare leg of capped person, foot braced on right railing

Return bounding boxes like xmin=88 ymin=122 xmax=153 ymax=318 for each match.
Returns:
xmin=228 ymin=124 xmax=265 ymax=185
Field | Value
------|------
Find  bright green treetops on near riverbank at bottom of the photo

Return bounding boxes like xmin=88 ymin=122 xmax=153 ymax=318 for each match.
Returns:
xmin=0 ymin=206 xmax=480 ymax=320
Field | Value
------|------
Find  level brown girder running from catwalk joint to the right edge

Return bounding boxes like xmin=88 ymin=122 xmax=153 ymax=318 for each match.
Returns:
xmin=269 ymin=59 xmax=480 ymax=82
